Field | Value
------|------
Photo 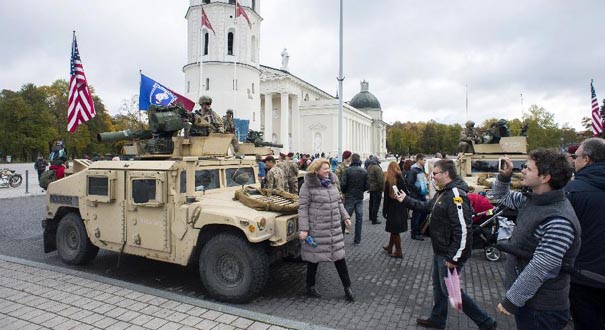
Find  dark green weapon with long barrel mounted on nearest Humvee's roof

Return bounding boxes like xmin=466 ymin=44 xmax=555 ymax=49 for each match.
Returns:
xmin=97 ymin=104 xmax=194 ymax=154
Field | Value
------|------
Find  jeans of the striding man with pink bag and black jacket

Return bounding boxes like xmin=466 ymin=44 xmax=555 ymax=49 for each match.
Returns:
xmin=430 ymin=255 xmax=495 ymax=329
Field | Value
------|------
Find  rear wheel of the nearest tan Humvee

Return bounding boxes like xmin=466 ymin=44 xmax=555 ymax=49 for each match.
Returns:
xmin=56 ymin=213 xmax=99 ymax=265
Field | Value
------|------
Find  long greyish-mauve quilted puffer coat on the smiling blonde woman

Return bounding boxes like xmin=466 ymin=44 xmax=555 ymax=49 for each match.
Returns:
xmin=298 ymin=173 xmax=349 ymax=263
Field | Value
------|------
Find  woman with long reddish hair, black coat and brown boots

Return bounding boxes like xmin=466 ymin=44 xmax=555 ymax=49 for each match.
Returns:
xmin=382 ymin=162 xmax=408 ymax=259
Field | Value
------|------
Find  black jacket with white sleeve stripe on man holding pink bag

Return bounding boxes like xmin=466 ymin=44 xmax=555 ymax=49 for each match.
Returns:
xmin=403 ymin=177 xmax=473 ymax=264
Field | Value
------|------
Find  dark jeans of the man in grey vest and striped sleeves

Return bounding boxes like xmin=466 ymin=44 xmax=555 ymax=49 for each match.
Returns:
xmin=515 ymin=306 xmax=568 ymax=330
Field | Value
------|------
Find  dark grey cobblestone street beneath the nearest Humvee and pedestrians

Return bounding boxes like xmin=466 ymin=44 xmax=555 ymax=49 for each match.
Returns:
xmin=0 ymin=186 xmax=515 ymax=330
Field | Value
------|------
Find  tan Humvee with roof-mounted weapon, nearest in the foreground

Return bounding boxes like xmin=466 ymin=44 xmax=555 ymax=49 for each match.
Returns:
xmin=43 ymin=104 xmax=299 ymax=303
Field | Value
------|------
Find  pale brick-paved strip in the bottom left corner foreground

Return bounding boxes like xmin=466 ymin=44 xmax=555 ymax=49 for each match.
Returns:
xmin=0 ymin=255 xmax=325 ymax=330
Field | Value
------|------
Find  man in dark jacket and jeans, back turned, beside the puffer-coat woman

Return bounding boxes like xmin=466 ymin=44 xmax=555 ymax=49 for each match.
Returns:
xmin=340 ymin=154 xmax=370 ymax=245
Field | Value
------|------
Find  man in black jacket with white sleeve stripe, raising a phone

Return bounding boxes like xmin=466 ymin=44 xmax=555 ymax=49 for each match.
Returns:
xmin=399 ymin=159 xmax=497 ymax=330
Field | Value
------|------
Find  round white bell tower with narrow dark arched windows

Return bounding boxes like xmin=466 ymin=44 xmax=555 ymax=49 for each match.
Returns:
xmin=183 ymin=0 xmax=262 ymax=131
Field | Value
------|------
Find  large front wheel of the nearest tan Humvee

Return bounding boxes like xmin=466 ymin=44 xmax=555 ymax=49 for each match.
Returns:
xmin=199 ymin=233 xmax=269 ymax=303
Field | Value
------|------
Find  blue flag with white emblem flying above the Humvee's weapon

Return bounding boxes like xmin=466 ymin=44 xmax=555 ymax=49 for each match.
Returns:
xmin=139 ymin=74 xmax=195 ymax=111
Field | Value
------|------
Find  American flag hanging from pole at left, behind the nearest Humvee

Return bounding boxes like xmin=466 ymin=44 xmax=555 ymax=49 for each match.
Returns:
xmin=67 ymin=32 xmax=95 ymax=133
